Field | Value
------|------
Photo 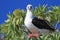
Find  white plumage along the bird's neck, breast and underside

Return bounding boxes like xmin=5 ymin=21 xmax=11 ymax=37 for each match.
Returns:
xmin=24 ymin=5 xmax=50 ymax=34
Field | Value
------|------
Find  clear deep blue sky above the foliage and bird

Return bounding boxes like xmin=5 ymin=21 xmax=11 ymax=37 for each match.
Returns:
xmin=0 ymin=0 xmax=60 ymax=24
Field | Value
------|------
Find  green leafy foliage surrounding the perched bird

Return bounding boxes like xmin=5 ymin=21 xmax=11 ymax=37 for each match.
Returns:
xmin=0 ymin=5 xmax=60 ymax=40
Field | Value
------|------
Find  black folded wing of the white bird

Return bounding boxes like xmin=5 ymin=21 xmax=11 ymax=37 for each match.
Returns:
xmin=32 ymin=17 xmax=55 ymax=31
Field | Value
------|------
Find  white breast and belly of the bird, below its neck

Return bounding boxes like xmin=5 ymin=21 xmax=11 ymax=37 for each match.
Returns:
xmin=24 ymin=19 xmax=39 ymax=33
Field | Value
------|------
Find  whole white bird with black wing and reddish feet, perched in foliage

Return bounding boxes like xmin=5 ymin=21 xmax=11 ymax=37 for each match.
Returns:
xmin=24 ymin=4 xmax=55 ymax=37
